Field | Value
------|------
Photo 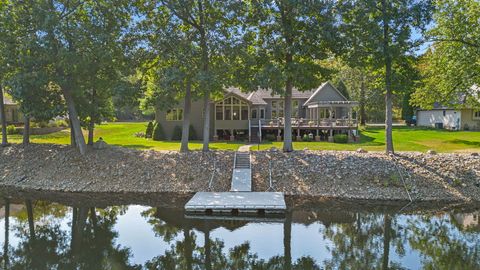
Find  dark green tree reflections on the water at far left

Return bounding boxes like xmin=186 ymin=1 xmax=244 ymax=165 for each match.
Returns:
xmin=6 ymin=201 xmax=141 ymax=269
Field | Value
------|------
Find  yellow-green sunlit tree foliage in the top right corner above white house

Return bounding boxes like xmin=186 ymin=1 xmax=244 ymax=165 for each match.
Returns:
xmin=412 ymin=0 xmax=480 ymax=109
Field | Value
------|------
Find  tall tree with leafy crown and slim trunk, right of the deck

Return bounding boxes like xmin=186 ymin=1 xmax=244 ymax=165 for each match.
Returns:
xmin=340 ymin=0 xmax=431 ymax=153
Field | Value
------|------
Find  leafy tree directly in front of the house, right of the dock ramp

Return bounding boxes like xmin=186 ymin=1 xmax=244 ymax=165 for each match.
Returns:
xmin=234 ymin=0 xmax=336 ymax=152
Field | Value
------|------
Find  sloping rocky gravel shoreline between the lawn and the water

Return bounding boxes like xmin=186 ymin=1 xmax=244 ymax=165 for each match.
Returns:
xmin=0 ymin=144 xmax=480 ymax=202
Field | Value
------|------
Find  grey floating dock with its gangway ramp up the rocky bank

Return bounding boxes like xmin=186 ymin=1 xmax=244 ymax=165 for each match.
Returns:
xmin=185 ymin=148 xmax=287 ymax=214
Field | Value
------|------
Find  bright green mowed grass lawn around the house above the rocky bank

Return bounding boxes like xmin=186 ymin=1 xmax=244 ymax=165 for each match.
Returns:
xmin=9 ymin=122 xmax=480 ymax=152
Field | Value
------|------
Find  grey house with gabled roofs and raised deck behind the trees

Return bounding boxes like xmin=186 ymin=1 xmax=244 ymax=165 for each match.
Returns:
xmin=155 ymin=82 xmax=358 ymax=141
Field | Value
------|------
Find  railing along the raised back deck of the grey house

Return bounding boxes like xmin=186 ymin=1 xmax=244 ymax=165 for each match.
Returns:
xmin=260 ymin=118 xmax=358 ymax=128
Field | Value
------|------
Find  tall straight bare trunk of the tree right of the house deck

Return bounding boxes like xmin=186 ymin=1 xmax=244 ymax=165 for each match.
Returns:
xmin=382 ymin=0 xmax=394 ymax=154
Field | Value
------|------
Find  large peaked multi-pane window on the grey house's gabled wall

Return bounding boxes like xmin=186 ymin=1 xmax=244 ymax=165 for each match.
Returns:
xmin=215 ymin=97 xmax=249 ymax=120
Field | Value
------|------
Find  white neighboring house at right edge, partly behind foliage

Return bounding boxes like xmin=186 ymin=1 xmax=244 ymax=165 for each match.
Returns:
xmin=416 ymin=85 xmax=480 ymax=130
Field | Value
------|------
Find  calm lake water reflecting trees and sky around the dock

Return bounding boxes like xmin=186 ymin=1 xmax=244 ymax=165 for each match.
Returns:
xmin=0 ymin=191 xmax=480 ymax=269
